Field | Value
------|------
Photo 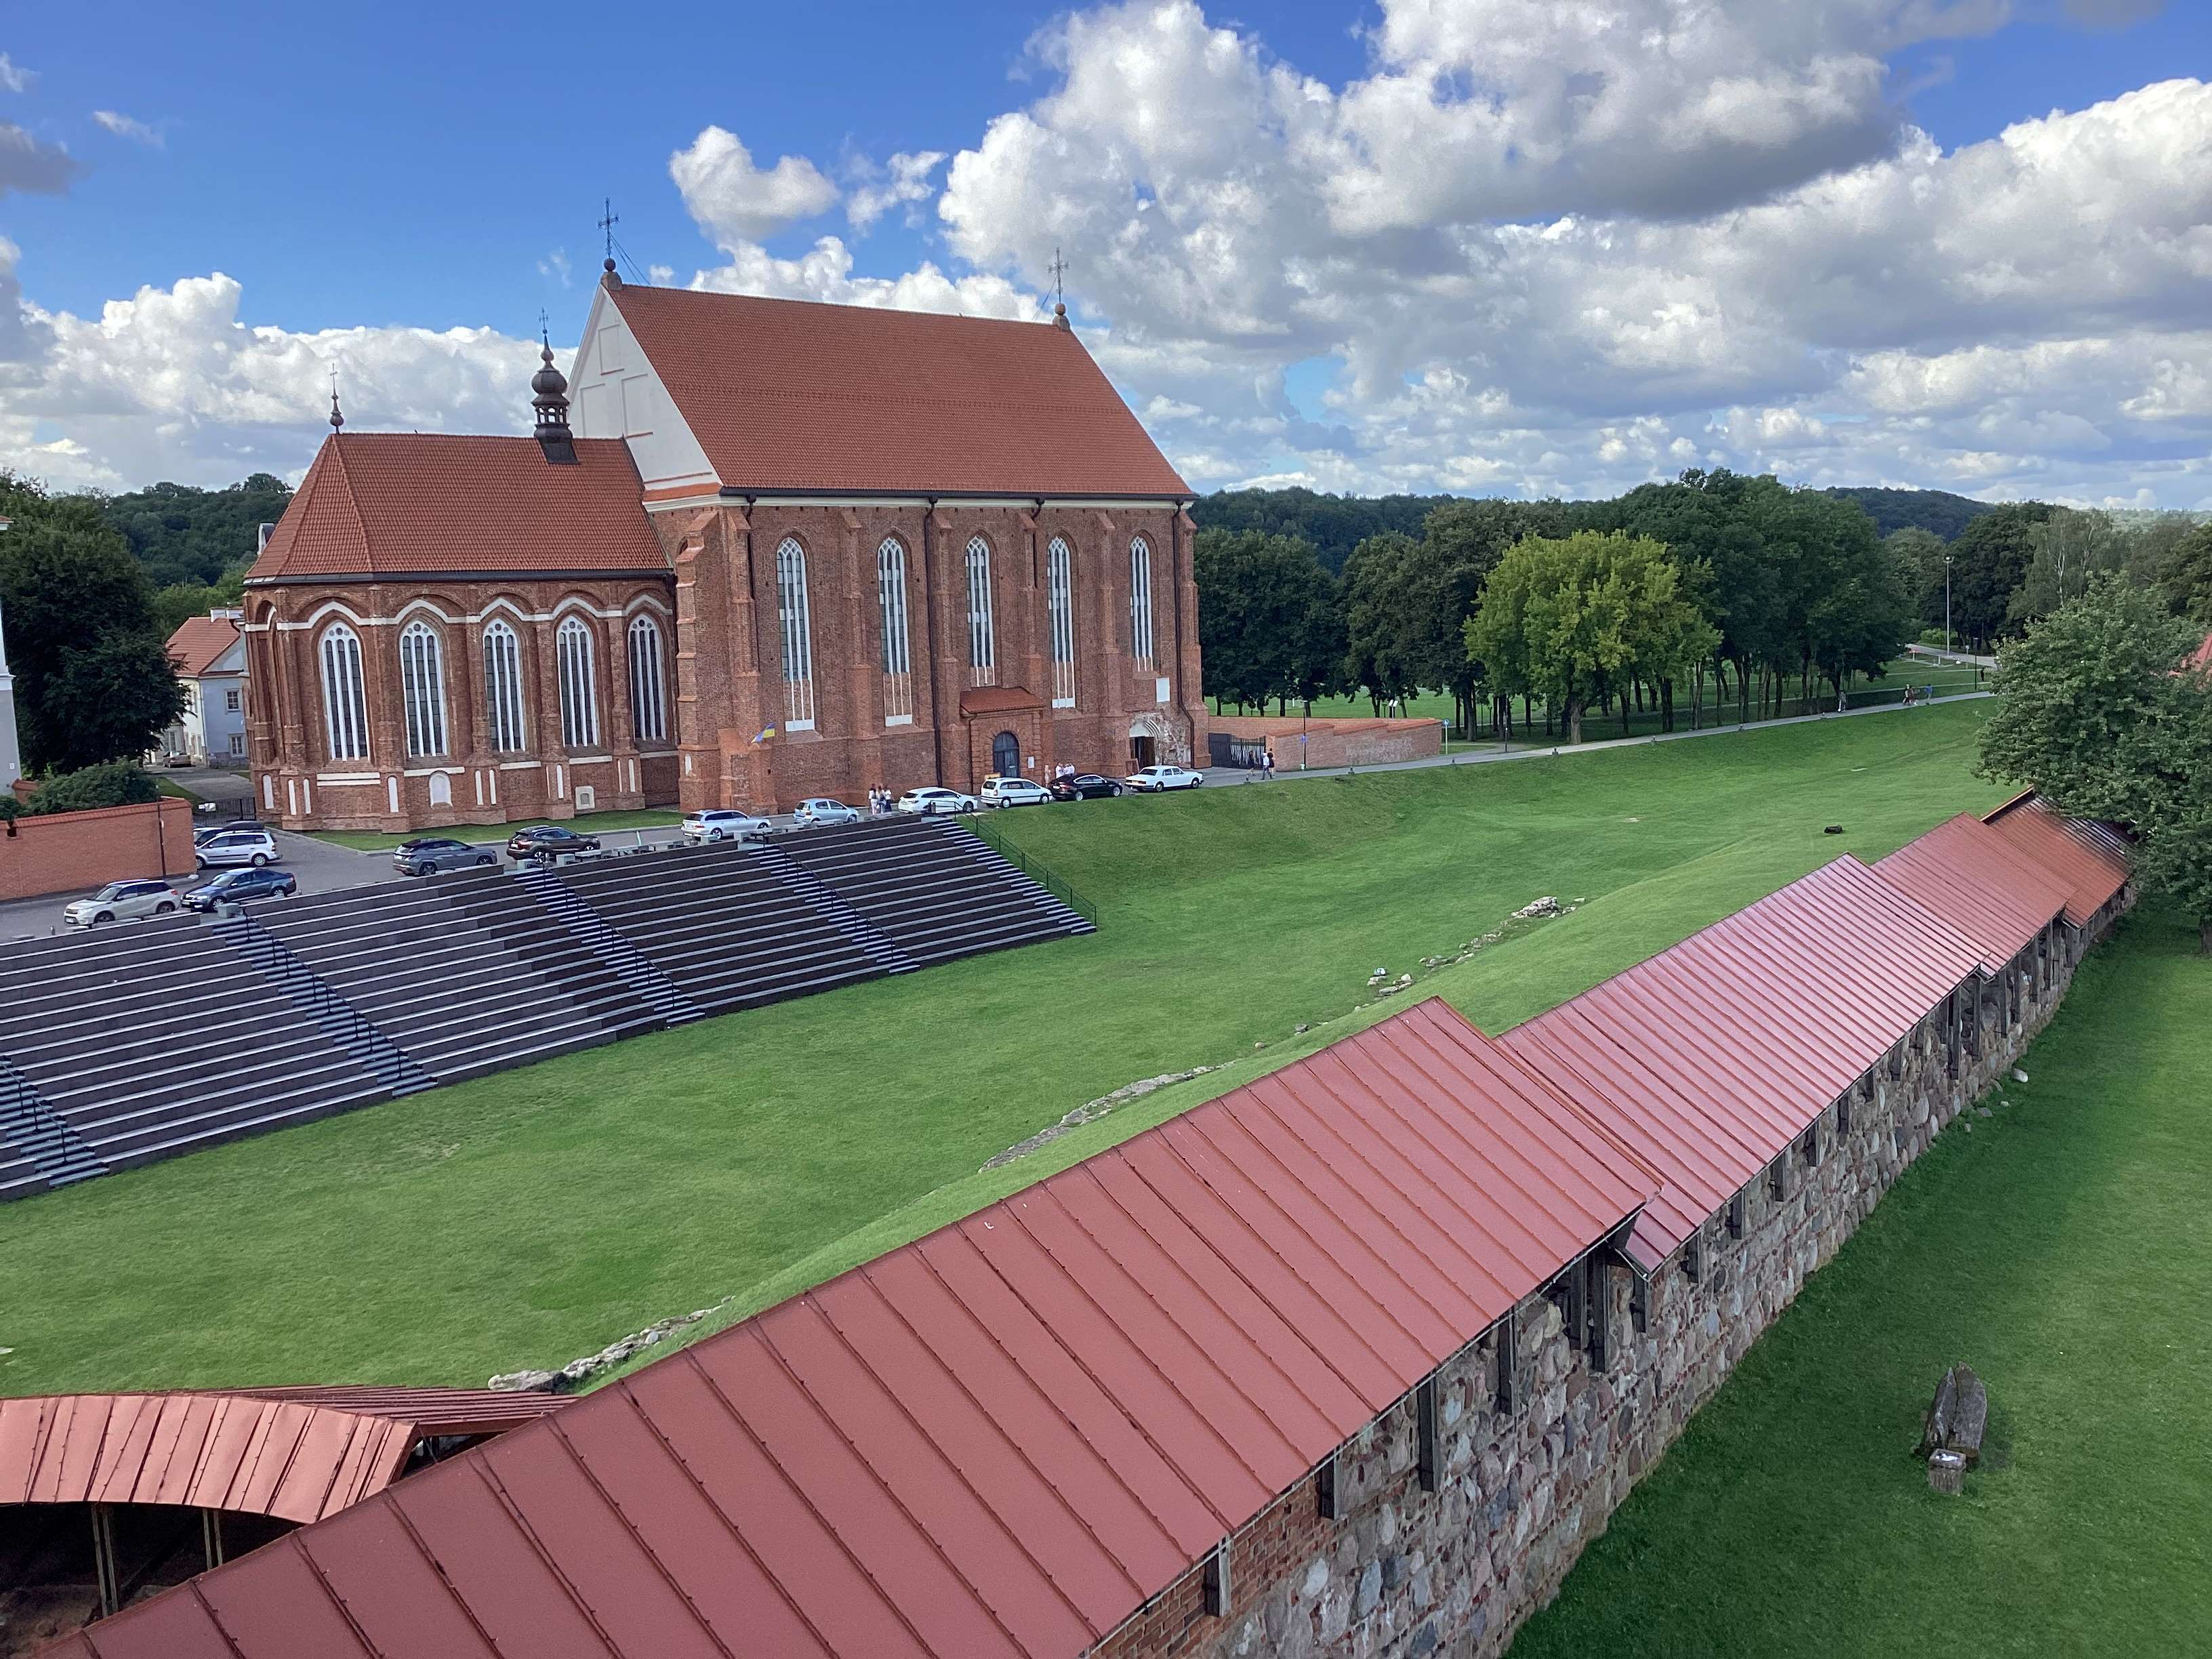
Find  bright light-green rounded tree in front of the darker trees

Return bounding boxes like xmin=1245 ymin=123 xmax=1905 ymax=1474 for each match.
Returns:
xmin=1465 ymin=531 xmax=1719 ymax=743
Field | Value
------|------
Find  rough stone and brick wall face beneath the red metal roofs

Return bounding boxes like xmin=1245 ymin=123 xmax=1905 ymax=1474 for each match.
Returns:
xmin=1092 ymin=887 xmax=2135 ymax=1659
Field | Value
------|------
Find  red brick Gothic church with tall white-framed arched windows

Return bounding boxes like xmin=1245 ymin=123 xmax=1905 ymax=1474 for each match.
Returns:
xmin=245 ymin=272 xmax=1206 ymax=830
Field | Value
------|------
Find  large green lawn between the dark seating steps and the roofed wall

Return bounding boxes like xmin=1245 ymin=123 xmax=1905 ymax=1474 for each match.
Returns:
xmin=0 ymin=703 xmax=2002 ymax=1393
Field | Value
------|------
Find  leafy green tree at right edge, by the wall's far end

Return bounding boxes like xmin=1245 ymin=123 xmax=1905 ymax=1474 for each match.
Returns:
xmin=1978 ymin=575 xmax=2212 ymax=954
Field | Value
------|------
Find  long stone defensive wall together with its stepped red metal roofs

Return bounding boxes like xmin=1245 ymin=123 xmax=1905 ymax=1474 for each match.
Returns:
xmin=53 ymin=796 xmax=2135 ymax=1659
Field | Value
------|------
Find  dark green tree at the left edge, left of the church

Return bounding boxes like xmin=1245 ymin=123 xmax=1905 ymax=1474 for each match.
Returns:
xmin=0 ymin=480 xmax=184 ymax=772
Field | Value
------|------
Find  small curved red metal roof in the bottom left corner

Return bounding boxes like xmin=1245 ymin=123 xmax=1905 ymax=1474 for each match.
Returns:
xmin=0 ymin=1387 xmax=573 ymax=1522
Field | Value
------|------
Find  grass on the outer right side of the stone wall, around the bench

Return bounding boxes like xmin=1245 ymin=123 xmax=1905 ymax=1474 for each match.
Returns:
xmin=1513 ymin=914 xmax=2212 ymax=1659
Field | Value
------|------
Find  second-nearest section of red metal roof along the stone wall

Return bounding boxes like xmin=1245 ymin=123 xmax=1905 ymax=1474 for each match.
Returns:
xmin=1502 ymin=858 xmax=1982 ymax=1267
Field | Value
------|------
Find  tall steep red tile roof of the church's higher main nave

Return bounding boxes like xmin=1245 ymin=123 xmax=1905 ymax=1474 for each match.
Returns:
xmin=609 ymin=287 xmax=1190 ymax=495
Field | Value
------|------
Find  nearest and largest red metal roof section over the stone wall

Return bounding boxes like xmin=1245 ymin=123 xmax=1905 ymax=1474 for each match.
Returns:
xmin=53 ymin=1002 xmax=1657 ymax=1659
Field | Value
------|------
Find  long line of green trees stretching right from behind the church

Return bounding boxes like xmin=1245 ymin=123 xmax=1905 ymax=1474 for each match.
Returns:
xmin=1195 ymin=469 xmax=2212 ymax=741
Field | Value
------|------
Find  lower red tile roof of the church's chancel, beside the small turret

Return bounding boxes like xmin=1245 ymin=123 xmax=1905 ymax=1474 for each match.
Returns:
xmin=245 ymin=431 xmax=668 ymax=581
